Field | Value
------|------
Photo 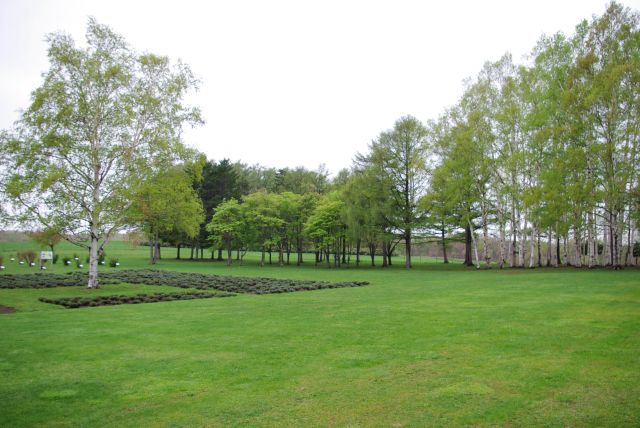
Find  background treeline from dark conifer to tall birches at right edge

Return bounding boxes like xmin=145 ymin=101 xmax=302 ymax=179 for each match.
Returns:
xmin=149 ymin=3 xmax=640 ymax=268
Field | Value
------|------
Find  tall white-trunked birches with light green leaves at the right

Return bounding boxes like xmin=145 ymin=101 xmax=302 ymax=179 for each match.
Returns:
xmin=425 ymin=3 xmax=640 ymax=267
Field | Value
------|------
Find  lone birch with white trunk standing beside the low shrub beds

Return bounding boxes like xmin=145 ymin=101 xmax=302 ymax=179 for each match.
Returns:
xmin=1 ymin=18 xmax=201 ymax=288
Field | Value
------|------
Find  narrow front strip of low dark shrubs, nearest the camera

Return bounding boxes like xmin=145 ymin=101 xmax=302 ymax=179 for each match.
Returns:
xmin=38 ymin=291 xmax=235 ymax=309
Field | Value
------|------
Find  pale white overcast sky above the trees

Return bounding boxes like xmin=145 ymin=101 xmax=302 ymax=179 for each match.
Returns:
xmin=0 ymin=0 xmax=640 ymax=174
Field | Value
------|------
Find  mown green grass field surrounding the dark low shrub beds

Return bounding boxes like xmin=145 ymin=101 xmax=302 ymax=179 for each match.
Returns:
xmin=0 ymin=242 xmax=640 ymax=427
